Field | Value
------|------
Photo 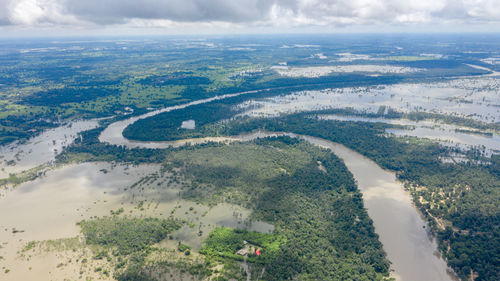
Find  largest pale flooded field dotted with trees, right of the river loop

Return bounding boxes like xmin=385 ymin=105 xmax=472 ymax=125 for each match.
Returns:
xmin=240 ymin=77 xmax=500 ymax=123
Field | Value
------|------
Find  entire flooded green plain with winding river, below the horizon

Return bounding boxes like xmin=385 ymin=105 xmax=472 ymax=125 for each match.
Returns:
xmin=0 ymin=36 xmax=500 ymax=281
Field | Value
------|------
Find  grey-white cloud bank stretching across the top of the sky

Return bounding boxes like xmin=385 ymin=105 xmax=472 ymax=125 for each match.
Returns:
xmin=0 ymin=0 xmax=500 ymax=27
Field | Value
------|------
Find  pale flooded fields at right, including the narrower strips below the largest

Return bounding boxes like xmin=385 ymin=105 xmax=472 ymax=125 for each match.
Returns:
xmin=235 ymin=74 xmax=500 ymax=156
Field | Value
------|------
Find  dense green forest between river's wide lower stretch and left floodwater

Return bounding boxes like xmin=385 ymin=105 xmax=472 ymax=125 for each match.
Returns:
xmin=164 ymin=138 xmax=389 ymax=280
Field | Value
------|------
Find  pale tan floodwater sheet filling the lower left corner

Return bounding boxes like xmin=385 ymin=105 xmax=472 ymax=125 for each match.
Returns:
xmin=0 ymin=163 xmax=156 ymax=281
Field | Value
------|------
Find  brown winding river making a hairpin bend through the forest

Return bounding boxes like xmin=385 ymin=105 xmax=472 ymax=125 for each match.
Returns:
xmin=99 ymin=99 xmax=455 ymax=281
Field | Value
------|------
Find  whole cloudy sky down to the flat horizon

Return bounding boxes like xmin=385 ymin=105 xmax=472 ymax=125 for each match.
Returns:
xmin=0 ymin=0 xmax=500 ymax=36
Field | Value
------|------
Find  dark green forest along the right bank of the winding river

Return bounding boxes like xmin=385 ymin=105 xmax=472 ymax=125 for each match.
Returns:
xmin=121 ymin=106 xmax=500 ymax=280
